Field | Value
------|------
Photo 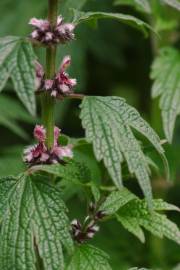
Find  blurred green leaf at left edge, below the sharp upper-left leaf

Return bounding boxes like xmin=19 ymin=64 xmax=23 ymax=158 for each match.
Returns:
xmin=0 ymin=95 xmax=34 ymax=139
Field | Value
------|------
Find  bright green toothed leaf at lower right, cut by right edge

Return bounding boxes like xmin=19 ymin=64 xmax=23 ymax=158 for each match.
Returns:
xmin=117 ymin=199 xmax=180 ymax=244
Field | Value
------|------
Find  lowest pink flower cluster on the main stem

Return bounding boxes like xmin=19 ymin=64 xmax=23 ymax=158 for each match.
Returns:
xmin=23 ymin=125 xmax=73 ymax=166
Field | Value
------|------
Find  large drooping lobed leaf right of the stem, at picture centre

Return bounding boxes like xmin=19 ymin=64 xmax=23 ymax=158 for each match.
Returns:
xmin=80 ymin=97 xmax=167 ymax=207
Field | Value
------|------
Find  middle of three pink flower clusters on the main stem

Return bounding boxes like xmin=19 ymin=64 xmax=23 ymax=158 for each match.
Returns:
xmin=36 ymin=56 xmax=77 ymax=97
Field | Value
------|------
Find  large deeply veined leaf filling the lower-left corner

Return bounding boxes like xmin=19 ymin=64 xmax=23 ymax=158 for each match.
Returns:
xmin=0 ymin=175 xmax=73 ymax=270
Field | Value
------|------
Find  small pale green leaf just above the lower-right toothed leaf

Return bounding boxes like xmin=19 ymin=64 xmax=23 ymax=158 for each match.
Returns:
xmin=100 ymin=188 xmax=136 ymax=215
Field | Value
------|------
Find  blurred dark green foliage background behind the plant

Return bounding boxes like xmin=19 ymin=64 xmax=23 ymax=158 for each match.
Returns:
xmin=0 ymin=0 xmax=180 ymax=270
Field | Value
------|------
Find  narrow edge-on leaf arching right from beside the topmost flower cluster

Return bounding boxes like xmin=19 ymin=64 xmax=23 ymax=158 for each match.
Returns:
xmin=73 ymin=9 xmax=153 ymax=33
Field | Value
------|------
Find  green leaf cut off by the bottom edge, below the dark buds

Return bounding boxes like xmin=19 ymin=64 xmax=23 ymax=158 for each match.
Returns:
xmin=66 ymin=245 xmax=111 ymax=270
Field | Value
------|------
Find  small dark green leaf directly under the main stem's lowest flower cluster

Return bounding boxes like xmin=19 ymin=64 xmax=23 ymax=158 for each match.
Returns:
xmin=32 ymin=160 xmax=91 ymax=184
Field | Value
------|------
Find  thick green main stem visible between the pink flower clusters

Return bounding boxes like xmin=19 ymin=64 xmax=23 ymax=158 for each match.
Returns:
xmin=41 ymin=0 xmax=58 ymax=149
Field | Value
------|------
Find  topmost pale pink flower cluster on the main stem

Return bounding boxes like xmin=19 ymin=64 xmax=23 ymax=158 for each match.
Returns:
xmin=29 ymin=16 xmax=75 ymax=45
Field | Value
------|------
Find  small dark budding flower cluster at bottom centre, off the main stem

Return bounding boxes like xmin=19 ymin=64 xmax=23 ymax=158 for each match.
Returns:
xmin=71 ymin=203 xmax=105 ymax=244
